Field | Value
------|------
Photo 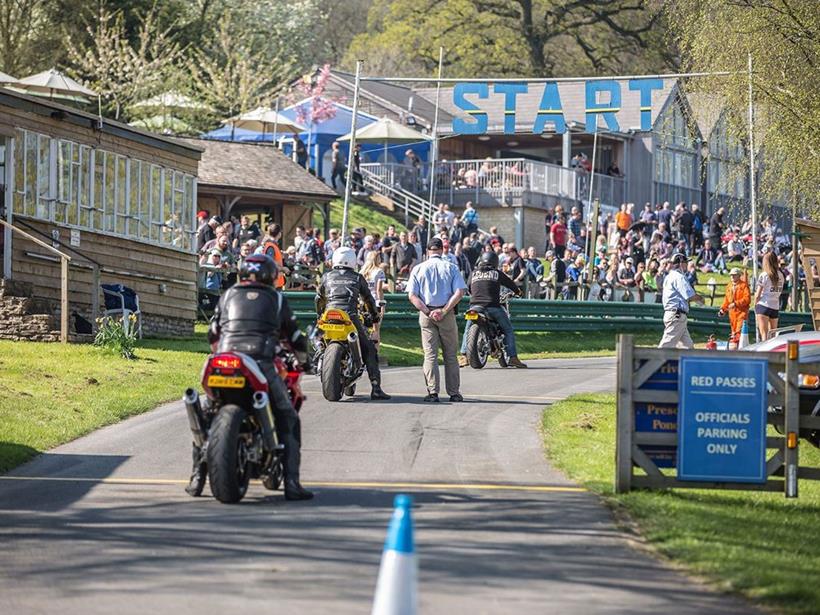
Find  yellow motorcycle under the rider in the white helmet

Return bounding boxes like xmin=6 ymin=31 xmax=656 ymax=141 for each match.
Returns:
xmin=314 ymin=308 xmax=373 ymax=401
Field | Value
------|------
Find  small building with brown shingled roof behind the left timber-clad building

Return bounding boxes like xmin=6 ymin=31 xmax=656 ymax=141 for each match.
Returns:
xmin=184 ymin=139 xmax=338 ymax=241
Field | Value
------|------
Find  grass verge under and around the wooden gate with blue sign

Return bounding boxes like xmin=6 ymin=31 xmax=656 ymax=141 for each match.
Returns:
xmin=543 ymin=395 xmax=820 ymax=615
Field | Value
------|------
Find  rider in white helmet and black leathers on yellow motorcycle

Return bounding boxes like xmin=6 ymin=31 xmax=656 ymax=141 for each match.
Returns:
xmin=316 ymin=247 xmax=390 ymax=399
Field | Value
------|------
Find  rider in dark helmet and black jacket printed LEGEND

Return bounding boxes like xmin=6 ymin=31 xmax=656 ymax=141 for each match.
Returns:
xmin=458 ymin=252 xmax=527 ymax=368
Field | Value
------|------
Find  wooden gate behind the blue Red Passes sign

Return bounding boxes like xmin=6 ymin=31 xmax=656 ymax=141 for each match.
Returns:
xmin=615 ymin=335 xmax=820 ymax=497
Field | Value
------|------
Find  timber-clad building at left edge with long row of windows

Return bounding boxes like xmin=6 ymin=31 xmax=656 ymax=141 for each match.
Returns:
xmin=0 ymin=89 xmax=202 ymax=339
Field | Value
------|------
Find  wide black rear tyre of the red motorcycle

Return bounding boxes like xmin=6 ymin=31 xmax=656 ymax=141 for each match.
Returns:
xmin=208 ymin=404 xmax=251 ymax=504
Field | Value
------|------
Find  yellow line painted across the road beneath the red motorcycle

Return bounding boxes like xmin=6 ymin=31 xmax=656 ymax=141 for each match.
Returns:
xmin=0 ymin=476 xmax=586 ymax=493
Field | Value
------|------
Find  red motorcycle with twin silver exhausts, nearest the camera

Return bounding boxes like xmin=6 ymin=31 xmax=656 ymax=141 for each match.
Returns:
xmin=183 ymin=347 xmax=306 ymax=504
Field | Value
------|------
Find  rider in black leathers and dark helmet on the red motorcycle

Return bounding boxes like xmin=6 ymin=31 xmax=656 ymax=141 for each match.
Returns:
xmin=208 ymin=254 xmax=313 ymax=500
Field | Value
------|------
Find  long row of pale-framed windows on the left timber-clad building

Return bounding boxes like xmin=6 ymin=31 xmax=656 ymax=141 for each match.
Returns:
xmin=13 ymin=130 xmax=196 ymax=252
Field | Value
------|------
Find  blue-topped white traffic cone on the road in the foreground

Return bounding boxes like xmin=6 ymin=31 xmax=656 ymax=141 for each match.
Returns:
xmin=371 ymin=495 xmax=418 ymax=615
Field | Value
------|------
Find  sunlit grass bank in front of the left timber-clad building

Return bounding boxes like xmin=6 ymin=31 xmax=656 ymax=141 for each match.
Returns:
xmin=0 ymin=330 xmax=208 ymax=472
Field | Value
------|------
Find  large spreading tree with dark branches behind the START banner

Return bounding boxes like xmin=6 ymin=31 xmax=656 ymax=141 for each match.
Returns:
xmin=345 ymin=0 xmax=675 ymax=77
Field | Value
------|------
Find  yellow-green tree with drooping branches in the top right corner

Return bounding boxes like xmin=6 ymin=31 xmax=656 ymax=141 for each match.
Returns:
xmin=667 ymin=0 xmax=820 ymax=214
